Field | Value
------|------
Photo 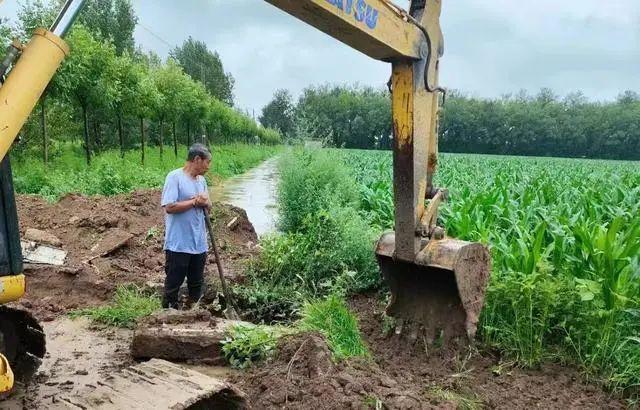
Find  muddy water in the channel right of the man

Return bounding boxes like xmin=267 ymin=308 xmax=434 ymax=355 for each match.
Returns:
xmin=211 ymin=158 xmax=278 ymax=236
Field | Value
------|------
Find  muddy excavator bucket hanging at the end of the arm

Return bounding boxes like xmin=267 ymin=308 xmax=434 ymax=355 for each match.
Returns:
xmin=376 ymin=232 xmax=491 ymax=343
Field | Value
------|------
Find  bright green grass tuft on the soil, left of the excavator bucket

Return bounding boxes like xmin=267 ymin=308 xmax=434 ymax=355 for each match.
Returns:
xmin=299 ymin=295 xmax=370 ymax=360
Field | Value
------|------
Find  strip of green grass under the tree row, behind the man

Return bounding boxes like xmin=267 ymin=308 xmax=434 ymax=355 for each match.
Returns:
xmin=12 ymin=144 xmax=281 ymax=200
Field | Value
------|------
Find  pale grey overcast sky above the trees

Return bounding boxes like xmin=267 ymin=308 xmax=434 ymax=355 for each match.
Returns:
xmin=0 ymin=0 xmax=640 ymax=115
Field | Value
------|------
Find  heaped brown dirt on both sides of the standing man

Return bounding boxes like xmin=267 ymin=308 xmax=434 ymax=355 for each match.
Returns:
xmin=17 ymin=190 xmax=257 ymax=320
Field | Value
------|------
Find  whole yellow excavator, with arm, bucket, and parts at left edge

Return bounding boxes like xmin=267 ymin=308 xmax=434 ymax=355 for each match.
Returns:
xmin=0 ymin=0 xmax=490 ymax=392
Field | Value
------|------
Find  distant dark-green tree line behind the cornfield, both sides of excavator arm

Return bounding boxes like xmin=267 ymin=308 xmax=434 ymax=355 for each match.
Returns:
xmin=260 ymin=86 xmax=640 ymax=160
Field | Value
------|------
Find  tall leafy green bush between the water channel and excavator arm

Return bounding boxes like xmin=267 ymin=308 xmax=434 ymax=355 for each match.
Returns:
xmin=238 ymin=151 xmax=380 ymax=322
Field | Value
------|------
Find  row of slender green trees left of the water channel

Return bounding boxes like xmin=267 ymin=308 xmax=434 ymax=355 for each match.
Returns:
xmin=0 ymin=0 xmax=281 ymax=163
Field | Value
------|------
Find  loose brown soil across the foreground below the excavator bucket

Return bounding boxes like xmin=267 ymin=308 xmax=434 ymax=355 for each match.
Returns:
xmin=232 ymin=295 xmax=625 ymax=409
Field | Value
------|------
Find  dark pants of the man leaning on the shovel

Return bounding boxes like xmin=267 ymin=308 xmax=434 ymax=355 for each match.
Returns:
xmin=162 ymin=251 xmax=207 ymax=308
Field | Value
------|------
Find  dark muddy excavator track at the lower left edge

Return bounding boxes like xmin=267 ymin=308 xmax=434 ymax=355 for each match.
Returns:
xmin=0 ymin=306 xmax=46 ymax=383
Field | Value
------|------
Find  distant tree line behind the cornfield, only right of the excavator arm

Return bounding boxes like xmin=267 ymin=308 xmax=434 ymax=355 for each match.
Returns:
xmin=440 ymin=89 xmax=640 ymax=159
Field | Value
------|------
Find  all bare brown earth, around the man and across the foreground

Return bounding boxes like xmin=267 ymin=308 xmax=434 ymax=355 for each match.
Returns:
xmin=0 ymin=191 xmax=624 ymax=409
